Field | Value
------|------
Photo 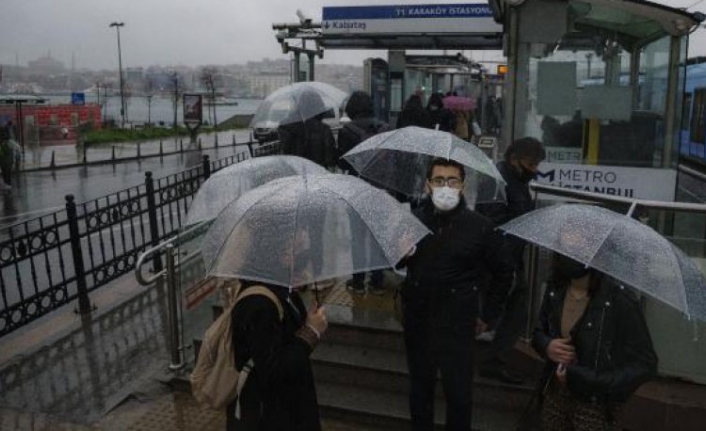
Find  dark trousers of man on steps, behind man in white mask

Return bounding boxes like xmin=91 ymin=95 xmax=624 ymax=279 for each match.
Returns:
xmin=480 ymin=270 xmax=527 ymax=370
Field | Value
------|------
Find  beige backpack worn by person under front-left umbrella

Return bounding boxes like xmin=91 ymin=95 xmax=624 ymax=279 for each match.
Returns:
xmin=191 ymin=286 xmax=284 ymax=418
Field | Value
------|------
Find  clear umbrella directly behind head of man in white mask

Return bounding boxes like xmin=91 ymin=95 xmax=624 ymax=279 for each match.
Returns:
xmin=343 ymin=126 xmax=505 ymax=206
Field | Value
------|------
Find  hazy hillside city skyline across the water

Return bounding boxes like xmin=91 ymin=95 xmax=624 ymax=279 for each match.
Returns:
xmin=0 ymin=53 xmax=363 ymax=99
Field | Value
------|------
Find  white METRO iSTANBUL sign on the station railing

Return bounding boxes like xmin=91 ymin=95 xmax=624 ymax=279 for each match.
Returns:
xmin=537 ymin=162 xmax=677 ymax=202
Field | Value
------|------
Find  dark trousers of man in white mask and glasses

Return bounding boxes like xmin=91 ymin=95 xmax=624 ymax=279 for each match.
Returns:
xmin=404 ymin=318 xmax=474 ymax=431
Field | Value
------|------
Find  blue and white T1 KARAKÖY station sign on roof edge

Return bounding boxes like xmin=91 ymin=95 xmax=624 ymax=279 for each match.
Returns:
xmin=321 ymin=3 xmax=503 ymax=34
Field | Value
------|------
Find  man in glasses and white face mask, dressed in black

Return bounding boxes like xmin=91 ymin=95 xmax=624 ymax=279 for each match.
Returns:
xmin=401 ymin=159 xmax=513 ymax=431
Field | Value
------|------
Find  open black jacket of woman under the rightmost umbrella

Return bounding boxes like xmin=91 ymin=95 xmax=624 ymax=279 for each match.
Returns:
xmin=532 ymin=278 xmax=657 ymax=405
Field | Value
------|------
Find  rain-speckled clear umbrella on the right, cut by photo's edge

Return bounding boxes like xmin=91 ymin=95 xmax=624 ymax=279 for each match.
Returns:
xmin=500 ymin=204 xmax=706 ymax=320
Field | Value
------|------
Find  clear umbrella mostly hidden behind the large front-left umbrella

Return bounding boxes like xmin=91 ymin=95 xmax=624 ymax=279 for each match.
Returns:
xmin=186 ymin=156 xmax=326 ymax=226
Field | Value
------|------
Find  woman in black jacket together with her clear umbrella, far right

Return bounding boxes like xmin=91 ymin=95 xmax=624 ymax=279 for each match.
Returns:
xmin=499 ymin=206 xmax=706 ymax=431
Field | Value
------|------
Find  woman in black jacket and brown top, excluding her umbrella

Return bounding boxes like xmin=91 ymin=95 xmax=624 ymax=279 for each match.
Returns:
xmin=532 ymin=253 xmax=657 ymax=431
